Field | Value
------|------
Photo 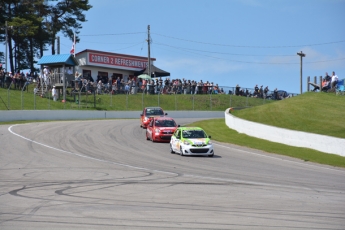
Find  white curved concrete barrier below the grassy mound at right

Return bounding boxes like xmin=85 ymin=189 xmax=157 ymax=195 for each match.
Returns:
xmin=225 ymin=109 xmax=345 ymax=156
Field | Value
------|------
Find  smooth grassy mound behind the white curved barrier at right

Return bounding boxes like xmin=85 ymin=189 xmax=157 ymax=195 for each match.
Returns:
xmin=233 ymin=92 xmax=345 ymax=138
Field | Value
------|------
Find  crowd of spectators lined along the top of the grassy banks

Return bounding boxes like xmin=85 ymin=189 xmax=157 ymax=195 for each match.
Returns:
xmin=0 ymin=67 xmax=338 ymax=100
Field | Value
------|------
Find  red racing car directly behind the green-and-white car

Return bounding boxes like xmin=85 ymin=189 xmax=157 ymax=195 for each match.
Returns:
xmin=146 ymin=117 xmax=179 ymax=142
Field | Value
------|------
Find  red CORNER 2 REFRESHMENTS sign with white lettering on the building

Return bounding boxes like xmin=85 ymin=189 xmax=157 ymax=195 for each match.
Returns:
xmin=89 ymin=53 xmax=148 ymax=70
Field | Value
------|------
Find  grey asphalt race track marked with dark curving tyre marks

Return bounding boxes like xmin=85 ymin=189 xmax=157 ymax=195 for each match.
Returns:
xmin=0 ymin=119 xmax=345 ymax=230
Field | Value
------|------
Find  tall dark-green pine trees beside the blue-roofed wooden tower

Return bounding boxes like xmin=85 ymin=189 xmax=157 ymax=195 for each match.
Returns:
xmin=0 ymin=0 xmax=92 ymax=73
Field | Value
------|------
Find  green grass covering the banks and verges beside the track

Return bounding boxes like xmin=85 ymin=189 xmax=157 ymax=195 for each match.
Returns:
xmin=0 ymin=85 xmax=345 ymax=167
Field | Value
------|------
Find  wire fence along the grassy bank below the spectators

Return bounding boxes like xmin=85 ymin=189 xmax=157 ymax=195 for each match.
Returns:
xmin=0 ymin=79 xmax=297 ymax=111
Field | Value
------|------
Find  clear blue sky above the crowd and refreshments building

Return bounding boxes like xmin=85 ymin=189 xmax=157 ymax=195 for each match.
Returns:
xmin=6 ymin=0 xmax=345 ymax=93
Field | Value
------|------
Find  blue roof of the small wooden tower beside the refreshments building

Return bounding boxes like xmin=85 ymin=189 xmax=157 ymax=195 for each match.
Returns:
xmin=37 ymin=54 xmax=79 ymax=66
